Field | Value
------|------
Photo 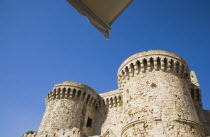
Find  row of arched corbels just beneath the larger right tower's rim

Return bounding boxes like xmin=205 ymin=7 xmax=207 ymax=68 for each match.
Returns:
xmin=118 ymin=55 xmax=188 ymax=86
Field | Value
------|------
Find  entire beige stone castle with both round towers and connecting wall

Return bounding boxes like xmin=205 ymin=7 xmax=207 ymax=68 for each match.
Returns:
xmin=27 ymin=50 xmax=210 ymax=137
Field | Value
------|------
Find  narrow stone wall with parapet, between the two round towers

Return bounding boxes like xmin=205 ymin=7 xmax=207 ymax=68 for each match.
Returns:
xmin=95 ymin=90 xmax=123 ymax=137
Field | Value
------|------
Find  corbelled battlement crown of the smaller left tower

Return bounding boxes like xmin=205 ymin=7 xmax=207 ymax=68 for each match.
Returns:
xmin=46 ymin=81 xmax=98 ymax=106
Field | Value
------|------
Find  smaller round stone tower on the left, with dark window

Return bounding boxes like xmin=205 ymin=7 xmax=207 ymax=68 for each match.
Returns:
xmin=38 ymin=82 xmax=98 ymax=137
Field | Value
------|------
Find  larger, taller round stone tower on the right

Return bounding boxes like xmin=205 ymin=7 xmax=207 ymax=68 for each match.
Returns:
xmin=118 ymin=50 xmax=204 ymax=137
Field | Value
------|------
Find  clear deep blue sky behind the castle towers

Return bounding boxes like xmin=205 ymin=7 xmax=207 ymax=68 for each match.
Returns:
xmin=0 ymin=0 xmax=210 ymax=137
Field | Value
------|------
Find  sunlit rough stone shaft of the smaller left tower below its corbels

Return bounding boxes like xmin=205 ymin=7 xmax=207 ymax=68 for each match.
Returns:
xmin=39 ymin=99 xmax=84 ymax=135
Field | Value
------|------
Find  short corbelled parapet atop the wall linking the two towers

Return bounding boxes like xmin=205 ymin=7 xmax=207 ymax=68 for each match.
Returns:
xmin=99 ymin=90 xmax=122 ymax=108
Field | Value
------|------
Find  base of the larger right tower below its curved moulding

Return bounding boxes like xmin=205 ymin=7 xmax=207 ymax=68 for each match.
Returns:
xmin=122 ymin=120 xmax=206 ymax=137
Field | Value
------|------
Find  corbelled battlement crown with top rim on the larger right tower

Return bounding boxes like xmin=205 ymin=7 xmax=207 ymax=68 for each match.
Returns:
xmin=118 ymin=50 xmax=189 ymax=85
